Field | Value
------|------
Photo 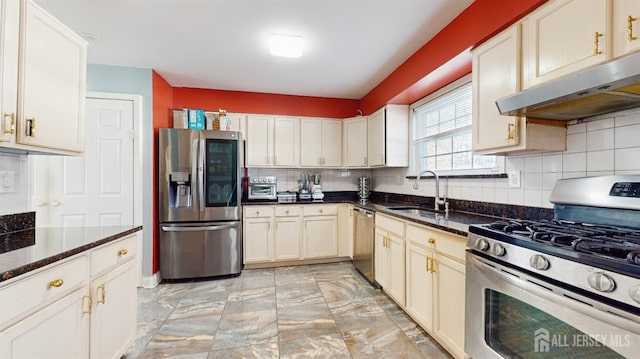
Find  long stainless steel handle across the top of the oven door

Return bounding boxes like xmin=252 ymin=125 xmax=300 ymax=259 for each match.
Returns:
xmin=466 ymin=252 xmax=640 ymax=334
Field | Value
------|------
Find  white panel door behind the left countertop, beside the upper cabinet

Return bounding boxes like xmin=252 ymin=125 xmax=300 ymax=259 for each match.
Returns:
xmin=33 ymin=98 xmax=134 ymax=227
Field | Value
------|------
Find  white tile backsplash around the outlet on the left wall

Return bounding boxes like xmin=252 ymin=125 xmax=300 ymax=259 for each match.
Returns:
xmin=0 ymin=153 xmax=30 ymax=215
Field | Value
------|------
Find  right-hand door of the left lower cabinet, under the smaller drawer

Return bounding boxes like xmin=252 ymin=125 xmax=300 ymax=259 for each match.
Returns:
xmin=90 ymin=260 xmax=137 ymax=358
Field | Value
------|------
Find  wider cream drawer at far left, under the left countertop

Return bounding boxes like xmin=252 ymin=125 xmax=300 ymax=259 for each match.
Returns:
xmin=0 ymin=255 xmax=89 ymax=329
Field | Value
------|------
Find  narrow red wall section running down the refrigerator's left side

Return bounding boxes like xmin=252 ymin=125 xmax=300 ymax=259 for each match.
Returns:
xmin=151 ymin=71 xmax=173 ymax=273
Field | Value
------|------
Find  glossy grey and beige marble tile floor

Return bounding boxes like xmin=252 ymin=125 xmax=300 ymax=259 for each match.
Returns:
xmin=125 ymin=262 xmax=450 ymax=359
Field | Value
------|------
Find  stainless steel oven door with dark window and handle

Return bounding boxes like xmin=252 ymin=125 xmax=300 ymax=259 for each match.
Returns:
xmin=465 ymin=251 xmax=640 ymax=359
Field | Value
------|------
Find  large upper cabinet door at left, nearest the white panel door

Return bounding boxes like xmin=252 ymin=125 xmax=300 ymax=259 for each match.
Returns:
xmin=18 ymin=1 xmax=87 ymax=151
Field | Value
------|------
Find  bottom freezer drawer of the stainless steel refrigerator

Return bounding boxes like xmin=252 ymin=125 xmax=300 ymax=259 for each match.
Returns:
xmin=160 ymin=221 xmax=243 ymax=279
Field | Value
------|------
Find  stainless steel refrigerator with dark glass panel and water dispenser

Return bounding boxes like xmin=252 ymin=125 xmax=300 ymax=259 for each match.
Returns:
xmin=158 ymin=128 xmax=243 ymax=279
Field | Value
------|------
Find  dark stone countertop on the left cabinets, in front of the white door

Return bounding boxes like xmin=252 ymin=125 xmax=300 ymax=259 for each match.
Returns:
xmin=0 ymin=226 xmax=142 ymax=282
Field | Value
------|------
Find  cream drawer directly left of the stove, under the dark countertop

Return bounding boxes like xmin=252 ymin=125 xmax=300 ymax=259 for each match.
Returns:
xmin=407 ymin=224 xmax=466 ymax=261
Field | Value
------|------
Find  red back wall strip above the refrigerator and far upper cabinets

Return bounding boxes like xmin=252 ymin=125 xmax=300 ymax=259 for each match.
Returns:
xmin=173 ymin=87 xmax=359 ymax=118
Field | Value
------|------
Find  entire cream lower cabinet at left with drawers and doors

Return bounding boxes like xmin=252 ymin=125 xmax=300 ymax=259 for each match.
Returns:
xmin=0 ymin=234 xmax=138 ymax=359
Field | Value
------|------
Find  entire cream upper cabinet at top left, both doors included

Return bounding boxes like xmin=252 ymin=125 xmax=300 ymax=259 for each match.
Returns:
xmin=0 ymin=0 xmax=87 ymax=154
